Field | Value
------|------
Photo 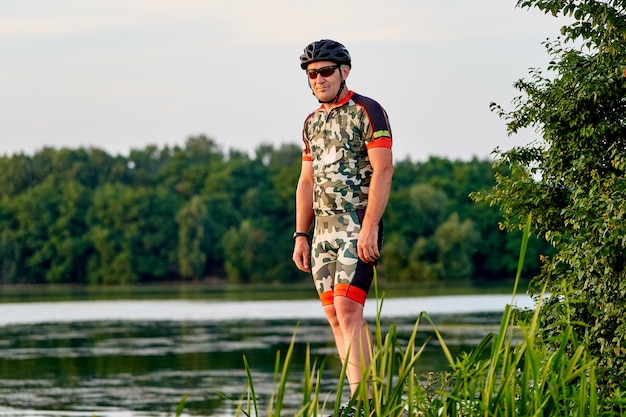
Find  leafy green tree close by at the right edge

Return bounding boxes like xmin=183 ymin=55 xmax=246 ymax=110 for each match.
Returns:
xmin=488 ymin=0 xmax=626 ymax=394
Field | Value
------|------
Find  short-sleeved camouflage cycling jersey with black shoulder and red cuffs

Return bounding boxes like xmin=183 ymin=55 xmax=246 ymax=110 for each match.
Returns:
xmin=302 ymin=91 xmax=392 ymax=216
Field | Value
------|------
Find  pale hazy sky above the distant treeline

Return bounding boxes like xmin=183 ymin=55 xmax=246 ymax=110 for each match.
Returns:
xmin=0 ymin=0 xmax=564 ymax=161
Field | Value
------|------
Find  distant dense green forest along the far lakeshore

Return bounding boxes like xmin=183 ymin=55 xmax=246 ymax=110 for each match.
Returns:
xmin=0 ymin=136 xmax=550 ymax=285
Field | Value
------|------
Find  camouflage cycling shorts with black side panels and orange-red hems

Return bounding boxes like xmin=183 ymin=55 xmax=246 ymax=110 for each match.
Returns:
xmin=311 ymin=210 xmax=382 ymax=305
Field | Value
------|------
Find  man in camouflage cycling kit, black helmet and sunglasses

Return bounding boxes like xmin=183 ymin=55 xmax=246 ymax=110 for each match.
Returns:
xmin=293 ymin=39 xmax=393 ymax=412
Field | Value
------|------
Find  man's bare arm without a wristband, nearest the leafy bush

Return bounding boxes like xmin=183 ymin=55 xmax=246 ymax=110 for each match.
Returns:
xmin=357 ymin=148 xmax=393 ymax=263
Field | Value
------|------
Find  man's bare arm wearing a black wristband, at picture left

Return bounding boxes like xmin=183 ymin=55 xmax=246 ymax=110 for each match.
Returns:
xmin=292 ymin=161 xmax=313 ymax=272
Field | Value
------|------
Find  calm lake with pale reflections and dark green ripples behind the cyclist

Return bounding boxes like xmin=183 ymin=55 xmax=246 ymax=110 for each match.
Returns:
xmin=0 ymin=294 xmax=533 ymax=417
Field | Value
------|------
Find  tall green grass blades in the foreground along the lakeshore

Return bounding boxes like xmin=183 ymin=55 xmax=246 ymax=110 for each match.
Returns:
xmin=196 ymin=217 xmax=626 ymax=417
